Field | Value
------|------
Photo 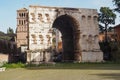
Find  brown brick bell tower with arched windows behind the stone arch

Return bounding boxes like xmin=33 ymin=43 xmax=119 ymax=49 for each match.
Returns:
xmin=16 ymin=8 xmax=29 ymax=48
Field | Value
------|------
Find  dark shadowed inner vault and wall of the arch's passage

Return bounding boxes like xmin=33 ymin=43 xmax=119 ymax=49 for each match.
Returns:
xmin=53 ymin=15 xmax=80 ymax=61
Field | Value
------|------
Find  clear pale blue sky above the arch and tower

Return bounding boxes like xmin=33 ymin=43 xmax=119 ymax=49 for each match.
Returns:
xmin=0 ymin=0 xmax=120 ymax=33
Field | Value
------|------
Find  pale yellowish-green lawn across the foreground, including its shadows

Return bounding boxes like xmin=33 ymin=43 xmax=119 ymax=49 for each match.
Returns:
xmin=0 ymin=63 xmax=120 ymax=80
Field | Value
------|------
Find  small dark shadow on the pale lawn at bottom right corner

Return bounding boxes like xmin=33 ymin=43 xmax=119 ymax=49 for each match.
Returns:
xmin=92 ymin=73 xmax=120 ymax=80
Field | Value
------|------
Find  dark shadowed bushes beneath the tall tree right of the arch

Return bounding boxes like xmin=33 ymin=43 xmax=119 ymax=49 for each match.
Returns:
xmin=100 ymin=42 xmax=120 ymax=62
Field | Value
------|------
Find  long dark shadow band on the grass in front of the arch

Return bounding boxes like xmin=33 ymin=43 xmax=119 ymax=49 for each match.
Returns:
xmin=25 ymin=63 xmax=120 ymax=70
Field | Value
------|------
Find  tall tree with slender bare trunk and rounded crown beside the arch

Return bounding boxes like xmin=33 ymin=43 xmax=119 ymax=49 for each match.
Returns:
xmin=98 ymin=7 xmax=116 ymax=42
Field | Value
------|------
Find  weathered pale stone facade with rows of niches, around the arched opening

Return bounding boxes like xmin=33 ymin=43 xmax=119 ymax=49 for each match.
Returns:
xmin=27 ymin=5 xmax=103 ymax=62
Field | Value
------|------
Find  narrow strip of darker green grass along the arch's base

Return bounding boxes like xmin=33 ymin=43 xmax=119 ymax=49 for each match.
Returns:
xmin=3 ymin=62 xmax=120 ymax=69
